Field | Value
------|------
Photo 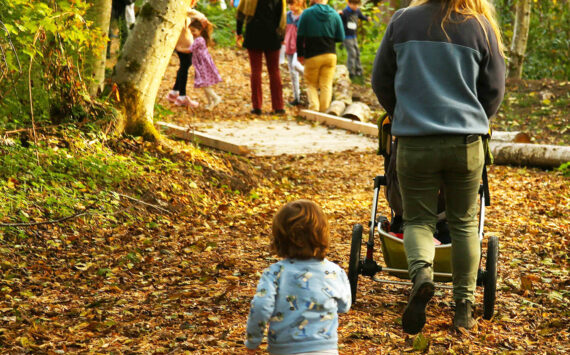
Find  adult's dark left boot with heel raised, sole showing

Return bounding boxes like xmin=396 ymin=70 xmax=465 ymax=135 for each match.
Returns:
xmin=402 ymin=265 xmax=435 ymax=334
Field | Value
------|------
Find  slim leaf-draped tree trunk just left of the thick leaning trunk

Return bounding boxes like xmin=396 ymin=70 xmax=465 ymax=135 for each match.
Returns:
xmin=83 ymin=0 xmax=113 ymax=96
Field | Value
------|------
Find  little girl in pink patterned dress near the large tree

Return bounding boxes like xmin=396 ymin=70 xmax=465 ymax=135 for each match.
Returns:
xmin=190 ymin=20 xmax=222 ymax=110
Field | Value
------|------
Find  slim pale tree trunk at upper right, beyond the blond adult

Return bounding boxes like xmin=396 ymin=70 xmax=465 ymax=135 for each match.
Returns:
xmin=509 ymin=0 xmax=532 ymax=79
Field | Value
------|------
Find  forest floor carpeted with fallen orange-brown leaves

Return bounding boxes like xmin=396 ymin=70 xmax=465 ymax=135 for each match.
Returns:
xmin=0 ymin=49 xmax=570 ymax=354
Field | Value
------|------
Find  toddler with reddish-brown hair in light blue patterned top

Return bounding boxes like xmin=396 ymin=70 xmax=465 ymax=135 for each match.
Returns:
xmin=245 ymin=200 xmax=351 ymax=354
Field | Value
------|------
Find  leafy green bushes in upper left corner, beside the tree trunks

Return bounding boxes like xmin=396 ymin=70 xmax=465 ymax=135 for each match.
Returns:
xmin=0 ymin=0 xmax=106 ymax=129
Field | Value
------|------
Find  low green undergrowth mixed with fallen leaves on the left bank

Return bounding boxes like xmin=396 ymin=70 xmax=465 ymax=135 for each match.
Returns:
xmin=0 ymin=126 xmax=248 ymax=239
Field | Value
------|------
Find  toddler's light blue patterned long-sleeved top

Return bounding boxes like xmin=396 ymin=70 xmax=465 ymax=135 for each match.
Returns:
xmin=245 ymin=259 xmax=351 ymax=354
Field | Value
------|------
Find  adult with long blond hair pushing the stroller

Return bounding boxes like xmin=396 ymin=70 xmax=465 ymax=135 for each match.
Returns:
xmin=372 ymin=0 xmax=505 ymax=334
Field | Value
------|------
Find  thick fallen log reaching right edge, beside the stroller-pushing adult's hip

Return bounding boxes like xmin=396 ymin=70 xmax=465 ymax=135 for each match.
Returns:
xmin=489 ymin=142 xmax=570 ymax=168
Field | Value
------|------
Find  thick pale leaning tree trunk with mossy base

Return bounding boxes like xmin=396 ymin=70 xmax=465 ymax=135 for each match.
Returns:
xmin=113 ymin=0 xmax=190 ymax=141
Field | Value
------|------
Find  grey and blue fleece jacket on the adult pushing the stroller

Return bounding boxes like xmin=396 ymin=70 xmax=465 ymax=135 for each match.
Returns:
xmin=372 ymin=1 xmax=505 ymax=136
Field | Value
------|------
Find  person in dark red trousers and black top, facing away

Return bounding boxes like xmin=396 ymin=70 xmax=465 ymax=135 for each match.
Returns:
xmin=236 ymin=0 xmax=287 ymax=115
